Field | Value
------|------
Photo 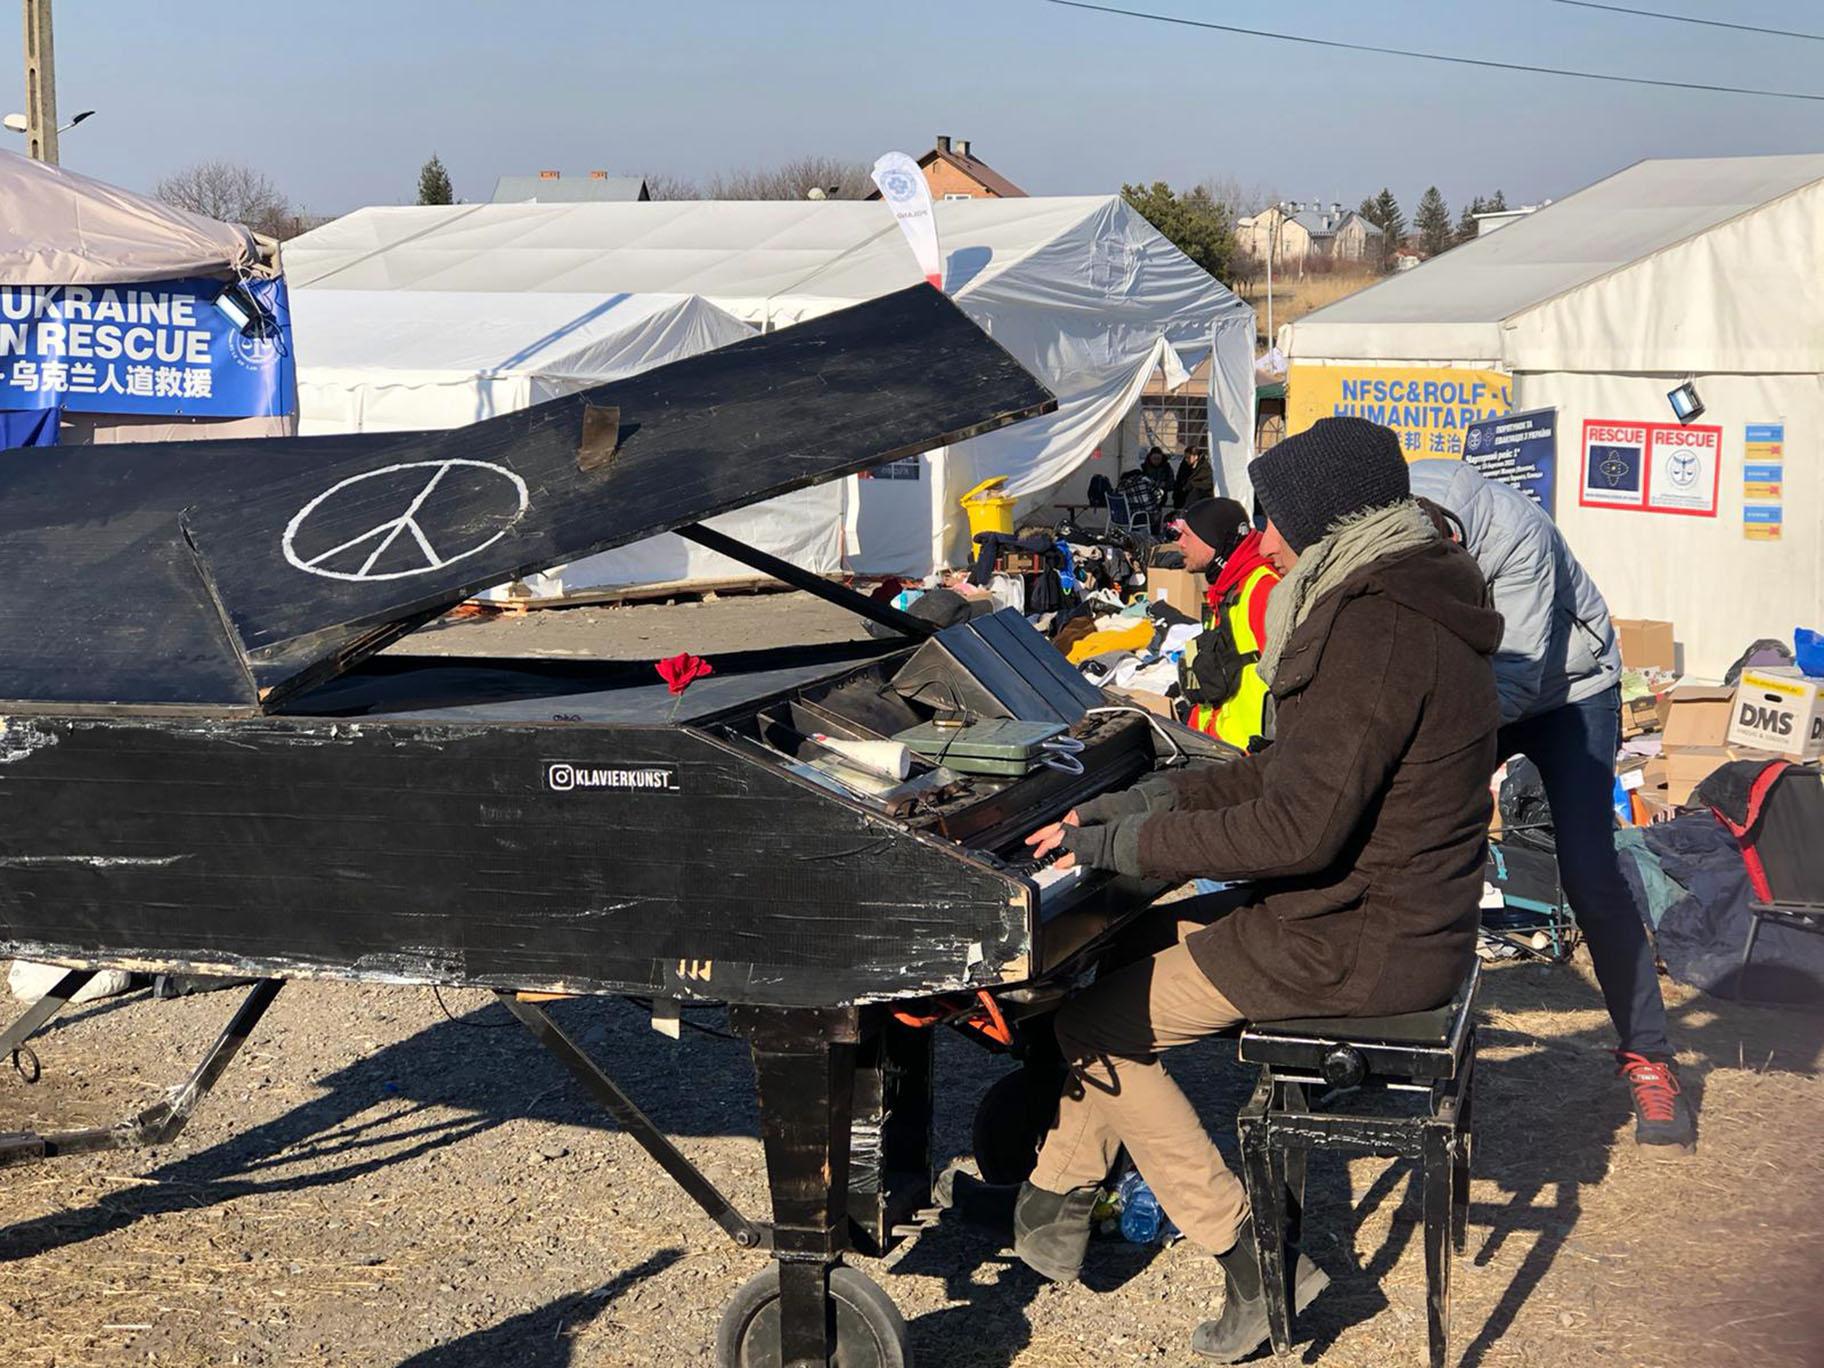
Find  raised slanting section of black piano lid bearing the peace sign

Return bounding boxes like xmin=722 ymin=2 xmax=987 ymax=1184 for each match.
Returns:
xmin=182 ymin=286 xmax=1056 ymax=718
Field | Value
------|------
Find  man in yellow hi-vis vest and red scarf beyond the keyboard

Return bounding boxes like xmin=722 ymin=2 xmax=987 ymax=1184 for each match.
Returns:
xmin=1176 ymin=498 xmax=1279 ymax=750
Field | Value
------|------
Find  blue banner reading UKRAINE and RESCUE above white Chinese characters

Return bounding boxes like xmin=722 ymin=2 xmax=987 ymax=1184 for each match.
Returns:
xmin=0 ymin=279 xmax=297 ymax=418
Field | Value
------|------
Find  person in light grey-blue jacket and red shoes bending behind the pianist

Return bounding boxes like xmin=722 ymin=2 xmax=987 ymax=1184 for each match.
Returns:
xmin=1412 ymin=460 xmax=1696 ymax=1156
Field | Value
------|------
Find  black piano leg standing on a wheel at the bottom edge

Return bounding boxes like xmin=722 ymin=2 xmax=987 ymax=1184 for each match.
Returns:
xmin=717 ymin=1007 xmax=910 ymax=1368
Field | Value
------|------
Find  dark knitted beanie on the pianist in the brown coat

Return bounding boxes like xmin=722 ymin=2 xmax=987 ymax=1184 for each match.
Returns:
xmin=1248 ymin=418 xmax=1412 ymax=554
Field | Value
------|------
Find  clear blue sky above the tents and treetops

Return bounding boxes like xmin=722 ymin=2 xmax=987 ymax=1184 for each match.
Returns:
xmin=0 ymin=0 xmax=1824 ymax=215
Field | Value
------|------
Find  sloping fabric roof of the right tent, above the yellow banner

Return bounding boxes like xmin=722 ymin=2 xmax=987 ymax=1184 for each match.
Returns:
xmin=1286 ymin=155 xmax=1824 ymax=361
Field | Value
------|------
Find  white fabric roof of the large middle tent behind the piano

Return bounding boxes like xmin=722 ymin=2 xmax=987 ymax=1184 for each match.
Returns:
xmin=285 ymin=195 xmax=1222 ymax=321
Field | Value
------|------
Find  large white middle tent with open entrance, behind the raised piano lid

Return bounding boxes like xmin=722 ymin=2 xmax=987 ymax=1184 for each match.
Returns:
xmin=285 ymin=197 xmax=1253 ymax=593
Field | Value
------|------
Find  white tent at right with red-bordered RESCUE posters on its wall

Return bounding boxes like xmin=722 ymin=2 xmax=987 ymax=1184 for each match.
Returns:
xmin=1280 ymin=155 xmax=1824 ymax=677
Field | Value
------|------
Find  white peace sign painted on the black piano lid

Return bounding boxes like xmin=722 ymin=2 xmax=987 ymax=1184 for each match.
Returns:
xmin=279 ymin=458 xmax=531 ymax=582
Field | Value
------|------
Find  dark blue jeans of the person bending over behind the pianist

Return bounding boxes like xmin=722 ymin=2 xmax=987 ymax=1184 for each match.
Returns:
xmin=1499 ymin=686 xmax=1673 ymax=1060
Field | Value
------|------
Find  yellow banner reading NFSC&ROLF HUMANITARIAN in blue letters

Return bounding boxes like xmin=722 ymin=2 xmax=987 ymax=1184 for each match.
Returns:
xmin=1286 ymin=363 xmax=1514 ymax=461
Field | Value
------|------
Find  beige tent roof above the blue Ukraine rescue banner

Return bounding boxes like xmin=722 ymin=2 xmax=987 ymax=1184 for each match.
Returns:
xmin=0 ymin=151 xmax=259 ymax=285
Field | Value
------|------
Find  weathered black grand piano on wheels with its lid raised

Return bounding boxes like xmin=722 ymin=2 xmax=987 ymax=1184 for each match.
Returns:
xmin=0 ymin=286 xmax=1207 ymax=1364
